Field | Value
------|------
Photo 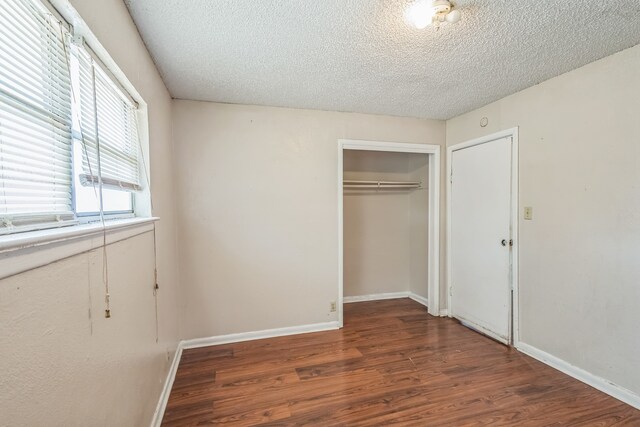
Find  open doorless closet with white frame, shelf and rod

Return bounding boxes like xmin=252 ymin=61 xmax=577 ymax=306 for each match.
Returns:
xmin=337 ymin=140 xmax=440 ymax=327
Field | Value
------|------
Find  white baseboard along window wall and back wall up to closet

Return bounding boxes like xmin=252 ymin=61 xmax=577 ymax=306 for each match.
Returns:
xmin=151 ymin=322 xmax=340 ymax=427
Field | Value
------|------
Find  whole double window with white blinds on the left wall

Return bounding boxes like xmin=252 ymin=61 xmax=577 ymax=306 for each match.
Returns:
xmin=0 ymin=0 xmax=142 ymax=234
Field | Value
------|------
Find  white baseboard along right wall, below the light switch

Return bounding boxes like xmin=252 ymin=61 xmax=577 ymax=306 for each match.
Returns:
xmin=516 ymin=342 xmax=640 ymax=409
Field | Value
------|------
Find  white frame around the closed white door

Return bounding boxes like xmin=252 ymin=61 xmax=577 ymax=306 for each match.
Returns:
xmin=446 ymin=127 xmax=520 ymax=346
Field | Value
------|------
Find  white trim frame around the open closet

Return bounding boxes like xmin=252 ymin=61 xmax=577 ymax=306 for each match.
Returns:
xmin=338 ymin=139 xmax=440 ymax=328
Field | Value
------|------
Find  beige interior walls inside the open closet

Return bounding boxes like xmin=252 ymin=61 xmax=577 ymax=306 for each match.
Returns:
xmin=343 ymin=150 xmax=429 ymax=298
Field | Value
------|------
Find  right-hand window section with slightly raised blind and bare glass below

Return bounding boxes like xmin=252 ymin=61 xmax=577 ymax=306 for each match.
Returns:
xmin=72 ymin=46 xmax=141 ymax=215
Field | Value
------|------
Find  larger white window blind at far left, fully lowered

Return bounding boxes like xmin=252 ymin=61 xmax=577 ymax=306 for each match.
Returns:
xmin=0 ymin=0 xmax=73 ymax=234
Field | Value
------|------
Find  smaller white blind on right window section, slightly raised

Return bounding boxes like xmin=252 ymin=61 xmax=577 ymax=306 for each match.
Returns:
xmin=77 ymin=48 xmax=142 ymax=191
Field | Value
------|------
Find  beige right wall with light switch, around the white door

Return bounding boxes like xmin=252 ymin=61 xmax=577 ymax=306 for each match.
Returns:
xmin=447 ymin=42 xmax=640 ymax=393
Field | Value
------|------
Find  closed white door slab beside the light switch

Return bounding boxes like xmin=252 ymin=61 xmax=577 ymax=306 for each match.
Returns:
xmin=450 ymin=137 xmax=512 ymax=343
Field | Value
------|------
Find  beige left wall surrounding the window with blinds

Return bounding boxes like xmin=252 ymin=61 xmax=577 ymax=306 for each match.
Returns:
xmin=0 ymin=0 xmax=179 ymax=426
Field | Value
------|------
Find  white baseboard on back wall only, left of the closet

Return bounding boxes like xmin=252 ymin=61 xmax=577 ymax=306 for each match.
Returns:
xmin=181 ymin=322 xmax=339 ymax=349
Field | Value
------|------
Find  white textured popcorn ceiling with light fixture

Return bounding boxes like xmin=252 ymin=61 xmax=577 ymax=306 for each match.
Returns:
xmin=126 ymin=0 xmax=640 ymax=119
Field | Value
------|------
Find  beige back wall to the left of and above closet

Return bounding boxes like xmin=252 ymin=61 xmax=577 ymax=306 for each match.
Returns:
xmin=173 ymin=100 xmax=444 ymax=338
